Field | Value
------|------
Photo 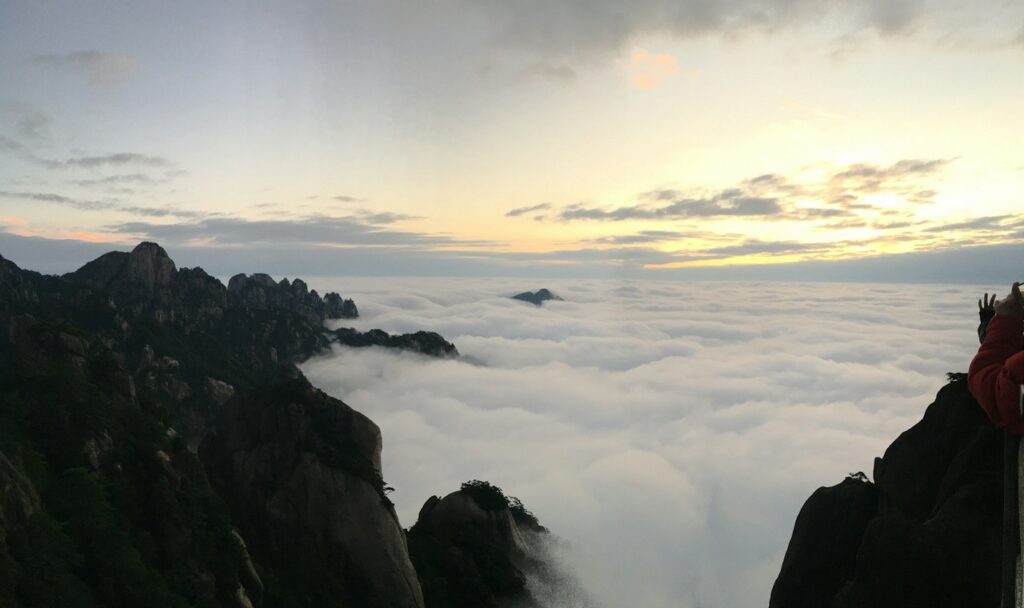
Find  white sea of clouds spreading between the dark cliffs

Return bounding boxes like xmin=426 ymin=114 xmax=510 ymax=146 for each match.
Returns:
xmin=303 ymin=277 xmax=980 ymax=608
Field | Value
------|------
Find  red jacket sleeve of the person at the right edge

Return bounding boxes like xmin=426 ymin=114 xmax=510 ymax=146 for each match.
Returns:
xmin=968 ymin=314 xmax=1024 ymax=427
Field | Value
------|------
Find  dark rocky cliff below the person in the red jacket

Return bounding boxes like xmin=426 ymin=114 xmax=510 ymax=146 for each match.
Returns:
xmin=770 ymin=375 xmax=1004 ymax=608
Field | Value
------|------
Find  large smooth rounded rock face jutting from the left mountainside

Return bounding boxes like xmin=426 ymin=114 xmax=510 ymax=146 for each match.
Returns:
xmin=200 ymin=371 xmax=423 ymax=608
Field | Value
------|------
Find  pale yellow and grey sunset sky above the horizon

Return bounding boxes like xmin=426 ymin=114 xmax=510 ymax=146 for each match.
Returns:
xmin=0 ymin=0 xmax=1024 ymax=283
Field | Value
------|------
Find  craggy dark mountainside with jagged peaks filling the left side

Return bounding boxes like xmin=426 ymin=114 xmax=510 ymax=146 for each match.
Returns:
xmin=0 ymin=243 xmax=565 ymax=608
